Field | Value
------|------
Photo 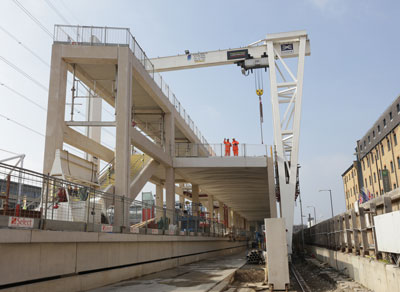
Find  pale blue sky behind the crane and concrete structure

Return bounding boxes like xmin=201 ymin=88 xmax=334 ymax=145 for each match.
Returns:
xmin=0 ymin=0 xmax=400 ymax=222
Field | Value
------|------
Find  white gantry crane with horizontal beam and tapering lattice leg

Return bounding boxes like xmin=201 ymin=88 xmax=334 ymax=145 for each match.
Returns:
xmin=151 ymin=31 xmax=310 ymax=253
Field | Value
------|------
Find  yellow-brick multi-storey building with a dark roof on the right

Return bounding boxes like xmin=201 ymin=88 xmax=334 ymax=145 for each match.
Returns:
xmin=342 ymin=96 xmax=400 ymax=209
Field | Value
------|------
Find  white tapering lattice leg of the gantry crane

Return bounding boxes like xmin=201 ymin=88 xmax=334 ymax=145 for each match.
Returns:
xmin=267 ymin=32 xmax=307 ymax=254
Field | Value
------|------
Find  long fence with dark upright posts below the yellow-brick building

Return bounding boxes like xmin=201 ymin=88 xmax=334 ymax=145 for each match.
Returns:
xmin=293 ymin=189 xmax=400 ymax=264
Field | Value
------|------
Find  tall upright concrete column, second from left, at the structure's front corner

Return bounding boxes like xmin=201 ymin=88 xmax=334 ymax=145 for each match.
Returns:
xmin=114 ymin=47 xmax=132 ymax=226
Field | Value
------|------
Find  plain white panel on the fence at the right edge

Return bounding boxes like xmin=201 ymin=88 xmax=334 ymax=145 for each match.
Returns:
xmin=374 ymin=211 xmax=400 ymax=254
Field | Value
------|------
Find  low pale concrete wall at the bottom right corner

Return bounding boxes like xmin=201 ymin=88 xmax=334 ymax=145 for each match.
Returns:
xmin=306 ymin=245 xmax=400 ymax=291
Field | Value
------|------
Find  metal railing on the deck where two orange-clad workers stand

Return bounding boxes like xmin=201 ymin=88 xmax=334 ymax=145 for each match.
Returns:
xmin=175 ymin=143 xmax=270 ymax=157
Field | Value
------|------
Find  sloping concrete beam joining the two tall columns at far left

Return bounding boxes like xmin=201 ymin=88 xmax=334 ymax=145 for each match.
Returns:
xmin=63 ymin=124 xmax=114 ymax=162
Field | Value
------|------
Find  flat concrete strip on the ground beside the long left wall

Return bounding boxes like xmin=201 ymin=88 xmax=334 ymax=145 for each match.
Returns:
xmin=86 ymin=252 xmax=246 ymax=292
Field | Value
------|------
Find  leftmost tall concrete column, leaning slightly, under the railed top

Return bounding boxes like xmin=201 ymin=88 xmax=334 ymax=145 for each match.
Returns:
xmin=43 ymin=45 xmax=67 ymax=174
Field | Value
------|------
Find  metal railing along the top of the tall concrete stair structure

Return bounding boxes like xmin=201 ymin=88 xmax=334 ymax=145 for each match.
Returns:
xmin=54 ymin=25 xmax=211 ymax=151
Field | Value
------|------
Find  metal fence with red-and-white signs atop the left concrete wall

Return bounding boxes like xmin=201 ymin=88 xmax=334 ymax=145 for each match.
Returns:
xmin=0 ymin=163 xmax=244 ymax=236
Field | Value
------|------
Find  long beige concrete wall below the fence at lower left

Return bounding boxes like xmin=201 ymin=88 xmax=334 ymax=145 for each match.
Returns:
xmin=0 ymin=229 xmax=246 ymax=291
